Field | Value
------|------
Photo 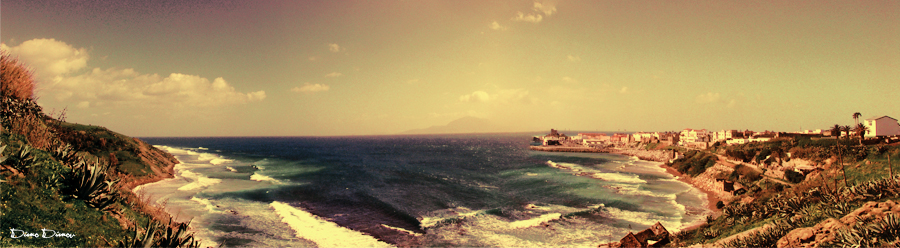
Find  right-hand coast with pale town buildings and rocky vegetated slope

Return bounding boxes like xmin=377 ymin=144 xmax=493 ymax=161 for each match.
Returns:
xmin=530 ymin=115 xmax=900 ymax=247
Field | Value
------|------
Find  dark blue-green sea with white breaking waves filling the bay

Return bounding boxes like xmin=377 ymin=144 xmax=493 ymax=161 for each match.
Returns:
xmin=136 ymin=133 xmax=709 ymax=247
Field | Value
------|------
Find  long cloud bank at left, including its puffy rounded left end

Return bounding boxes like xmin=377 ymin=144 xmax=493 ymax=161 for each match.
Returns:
xmin=4 ymin=39 xmax=266 ymax=109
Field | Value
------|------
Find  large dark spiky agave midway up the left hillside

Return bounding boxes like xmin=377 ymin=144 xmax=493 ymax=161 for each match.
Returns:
xmin=66 ymin=160 xmax=119 ymax=210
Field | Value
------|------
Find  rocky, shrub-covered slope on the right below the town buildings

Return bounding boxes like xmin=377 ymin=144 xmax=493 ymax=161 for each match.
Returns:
xmin=668 ymin=135 xmax=900 ymax=247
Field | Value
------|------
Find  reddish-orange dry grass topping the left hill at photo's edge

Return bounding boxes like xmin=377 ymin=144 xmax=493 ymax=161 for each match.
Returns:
xmin=0 ymin=51 xmax=34 ymax=100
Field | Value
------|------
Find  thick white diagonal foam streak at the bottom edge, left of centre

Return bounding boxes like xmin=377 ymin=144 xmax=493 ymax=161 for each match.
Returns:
xmin=269 ymin=201 xmax=392 ymax=247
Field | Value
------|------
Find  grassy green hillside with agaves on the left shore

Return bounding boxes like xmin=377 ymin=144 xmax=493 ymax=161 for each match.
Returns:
xmin=0 ymin=52 xmax=198 ymax=247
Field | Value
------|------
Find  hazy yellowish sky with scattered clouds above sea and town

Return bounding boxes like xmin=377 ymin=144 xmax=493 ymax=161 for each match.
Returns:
xmin=0 ymin=0 xmax=900 ymax=137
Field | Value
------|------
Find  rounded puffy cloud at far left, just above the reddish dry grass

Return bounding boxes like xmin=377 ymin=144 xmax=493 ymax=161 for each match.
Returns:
xmin=3 ymin=39 xmax=90 ymax=79
